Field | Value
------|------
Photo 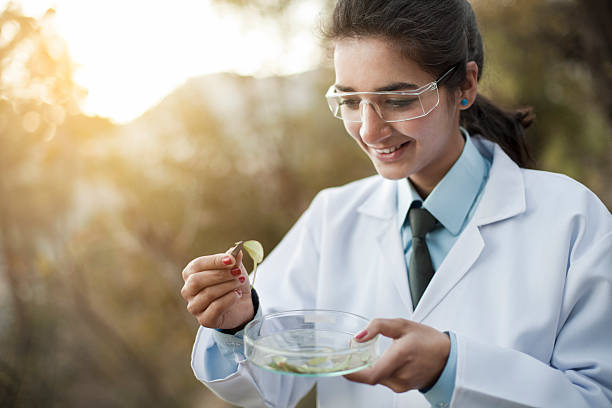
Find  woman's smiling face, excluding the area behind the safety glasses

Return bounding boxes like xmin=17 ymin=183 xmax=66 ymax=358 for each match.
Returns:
xmin=334 ymin=38 xmax=464 ymax=194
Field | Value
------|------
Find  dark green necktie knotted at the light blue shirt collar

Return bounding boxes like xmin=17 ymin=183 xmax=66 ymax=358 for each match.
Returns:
xmin=408 ymin=208 xmax=437 ymax=309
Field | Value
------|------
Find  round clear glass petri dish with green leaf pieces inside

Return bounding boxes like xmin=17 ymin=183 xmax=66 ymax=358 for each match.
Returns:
xmin=244 ymin=310 xmax=378 ymax=377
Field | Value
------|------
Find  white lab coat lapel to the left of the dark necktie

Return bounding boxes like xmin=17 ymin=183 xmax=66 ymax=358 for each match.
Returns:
xmin=358 ymin=180 xmax=412 ymax=311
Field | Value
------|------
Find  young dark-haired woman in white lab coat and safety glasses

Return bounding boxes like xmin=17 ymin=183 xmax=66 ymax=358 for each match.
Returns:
xmin=182 ymin=0 xmax=612 ymax=408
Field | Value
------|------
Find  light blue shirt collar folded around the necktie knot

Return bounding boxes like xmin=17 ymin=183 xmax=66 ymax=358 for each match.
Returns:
xmin=397 ymin=128 xmax=489 ymax=235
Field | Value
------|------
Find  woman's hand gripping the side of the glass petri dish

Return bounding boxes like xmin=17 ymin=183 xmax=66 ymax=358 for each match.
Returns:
xmin=344 ymin=319 xmax=450 ymax=392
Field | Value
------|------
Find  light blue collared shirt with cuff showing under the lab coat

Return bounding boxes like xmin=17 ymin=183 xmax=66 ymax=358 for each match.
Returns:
xmin=397 ymin=128 xmax=491 ymax=406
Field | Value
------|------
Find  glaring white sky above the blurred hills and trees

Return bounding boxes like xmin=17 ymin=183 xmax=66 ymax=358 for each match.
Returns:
xmin=0 ymin=0 xmax=322 ymax=123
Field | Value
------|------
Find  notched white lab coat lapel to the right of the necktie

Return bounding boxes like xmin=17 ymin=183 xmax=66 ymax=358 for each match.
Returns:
xmin=412 ymin=145 xmax=525 ymax=322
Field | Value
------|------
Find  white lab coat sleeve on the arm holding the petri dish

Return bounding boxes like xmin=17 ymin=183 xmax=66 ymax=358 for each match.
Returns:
xmin=451 ymin=232 xmax=612 ymax=408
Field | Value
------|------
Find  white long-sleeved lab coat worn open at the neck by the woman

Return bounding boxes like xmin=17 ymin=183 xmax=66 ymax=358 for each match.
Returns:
xmin=192 ymin=139 xmax=612 ymax=408
